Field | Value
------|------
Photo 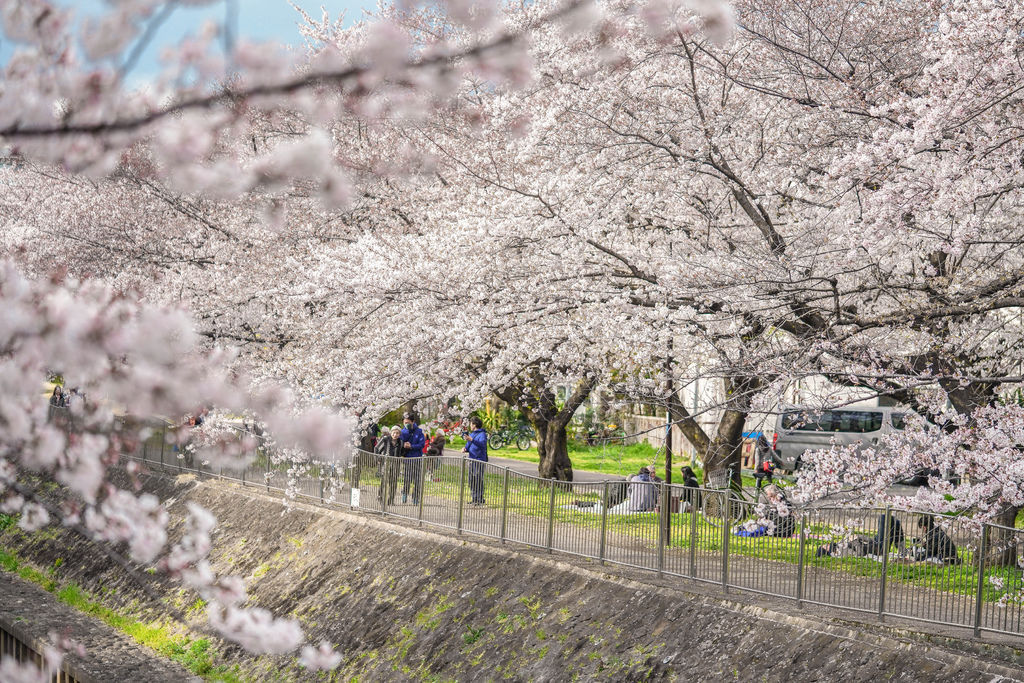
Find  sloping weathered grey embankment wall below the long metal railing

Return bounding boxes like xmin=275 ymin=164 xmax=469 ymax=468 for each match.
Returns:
xmin=0 ymin=477 xmax=1024 ymax=682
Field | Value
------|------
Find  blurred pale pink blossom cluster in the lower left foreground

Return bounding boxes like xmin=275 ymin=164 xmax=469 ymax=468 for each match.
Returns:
xmin=0 ymin=262 xmax=348 ymax=667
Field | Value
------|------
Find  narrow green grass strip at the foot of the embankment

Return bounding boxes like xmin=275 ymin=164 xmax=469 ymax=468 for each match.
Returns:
xmin=0 ymin=548 xmax=246 ymax=683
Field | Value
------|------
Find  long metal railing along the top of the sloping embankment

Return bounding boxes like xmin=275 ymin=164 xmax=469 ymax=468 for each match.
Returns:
xmin=123 ymin=427 xmax=1024 ymax=636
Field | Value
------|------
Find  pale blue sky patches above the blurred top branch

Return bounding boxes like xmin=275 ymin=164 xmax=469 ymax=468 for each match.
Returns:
xmin=0 ymin=0 xmax=376 ymax=80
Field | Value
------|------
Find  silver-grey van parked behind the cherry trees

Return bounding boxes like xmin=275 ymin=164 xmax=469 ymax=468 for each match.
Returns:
xmin=772 ymin=407 xmax=910 ymax=472
